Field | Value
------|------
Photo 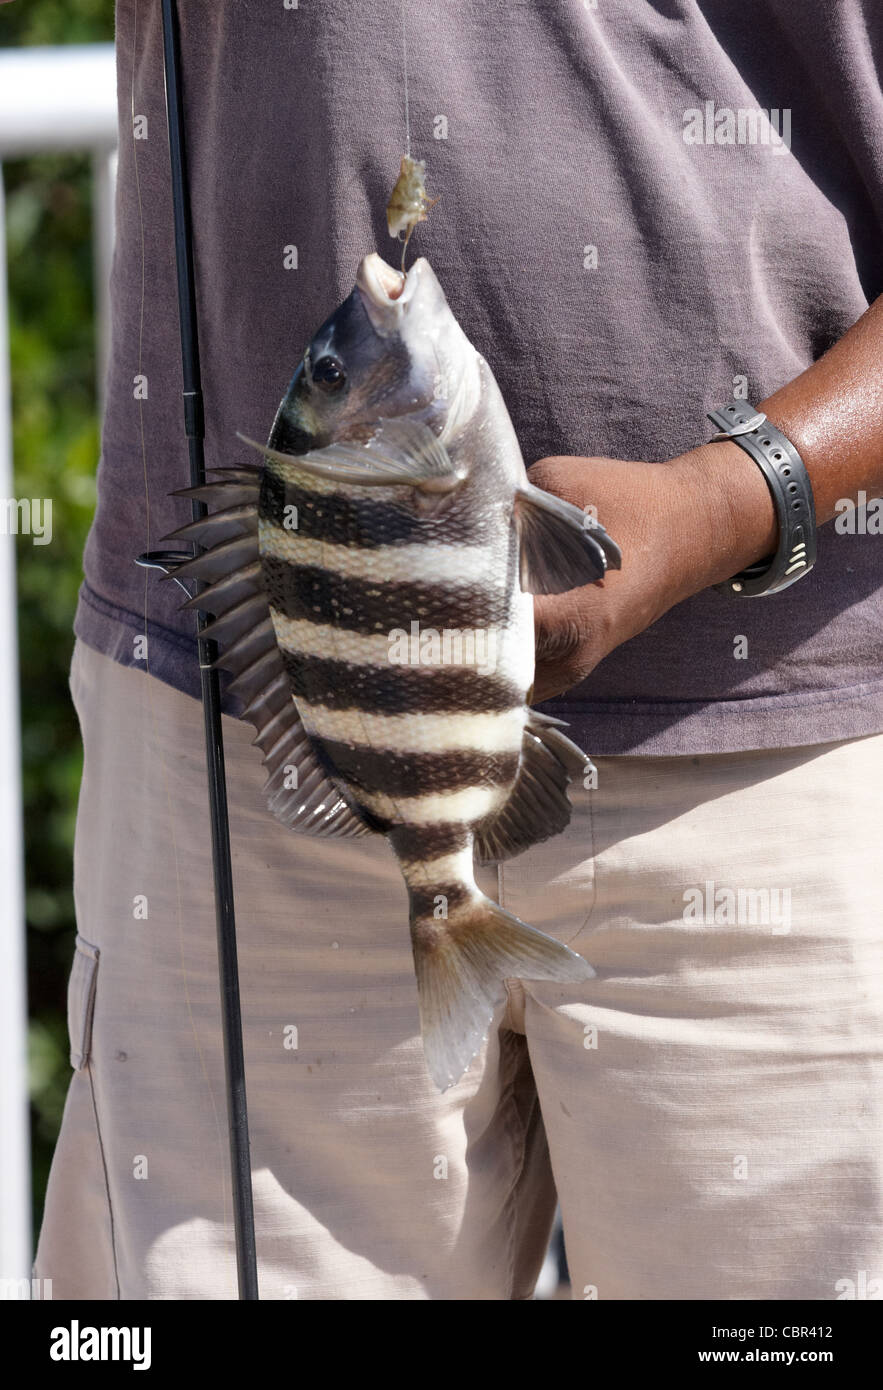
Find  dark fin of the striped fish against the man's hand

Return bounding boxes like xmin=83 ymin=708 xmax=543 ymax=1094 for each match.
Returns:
xmin=515 ymin=482 xmax=622 ymax=594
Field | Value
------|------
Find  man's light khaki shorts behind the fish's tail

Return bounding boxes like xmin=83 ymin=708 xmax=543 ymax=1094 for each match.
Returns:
xmin=35 ymin=642 xmax=883 ymax=1300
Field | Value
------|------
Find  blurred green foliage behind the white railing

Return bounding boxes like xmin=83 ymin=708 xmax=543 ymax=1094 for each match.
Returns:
xmin=0 ymin=0 xmax=113 ymax=1239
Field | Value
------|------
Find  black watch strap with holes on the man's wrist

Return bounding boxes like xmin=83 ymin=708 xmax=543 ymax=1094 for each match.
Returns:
xmin=708 ymin=400 xmax=816 ymax=599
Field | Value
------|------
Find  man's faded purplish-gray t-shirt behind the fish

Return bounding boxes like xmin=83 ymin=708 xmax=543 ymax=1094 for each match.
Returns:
xmin=75 ymin=0 xmax=883 ymax=753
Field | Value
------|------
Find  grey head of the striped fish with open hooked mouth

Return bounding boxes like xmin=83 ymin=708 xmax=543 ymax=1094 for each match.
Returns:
xmin=270 ymin=252 xmax=483 ymax=453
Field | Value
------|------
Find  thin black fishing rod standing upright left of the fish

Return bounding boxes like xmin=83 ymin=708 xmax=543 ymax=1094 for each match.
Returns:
xmin=139 ymin=0 xmax=259 ymax=1300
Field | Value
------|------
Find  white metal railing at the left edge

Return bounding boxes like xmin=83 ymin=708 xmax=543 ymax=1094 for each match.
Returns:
xmin=0 ymin=43 xmax=117 ymax=1280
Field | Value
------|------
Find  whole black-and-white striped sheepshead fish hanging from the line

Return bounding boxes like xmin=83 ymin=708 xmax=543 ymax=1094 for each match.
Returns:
xmin=168 ymin=254 xmax=620 ymax=1090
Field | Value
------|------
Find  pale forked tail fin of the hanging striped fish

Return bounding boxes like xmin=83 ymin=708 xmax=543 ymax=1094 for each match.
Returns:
xmin=410 ymin=894 xmax=595 ymax=1091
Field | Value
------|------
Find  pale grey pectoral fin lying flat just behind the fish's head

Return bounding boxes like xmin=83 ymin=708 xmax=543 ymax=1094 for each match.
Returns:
xmin=239 ymin=416 xmax=466 ymax=492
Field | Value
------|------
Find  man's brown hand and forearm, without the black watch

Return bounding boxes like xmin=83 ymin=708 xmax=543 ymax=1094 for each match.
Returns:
xmin=528 ymin=296 xmax=883 ymax=702
